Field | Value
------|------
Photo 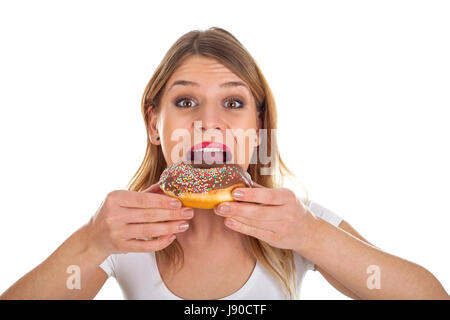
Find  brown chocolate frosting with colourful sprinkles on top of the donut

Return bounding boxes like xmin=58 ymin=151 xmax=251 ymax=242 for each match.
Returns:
xmin=159 ymin=162 xmax=252 ymax=195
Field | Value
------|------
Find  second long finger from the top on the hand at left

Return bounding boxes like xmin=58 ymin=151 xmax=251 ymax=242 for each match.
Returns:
xmin=123 ymin=207 xmax=194 ymax=223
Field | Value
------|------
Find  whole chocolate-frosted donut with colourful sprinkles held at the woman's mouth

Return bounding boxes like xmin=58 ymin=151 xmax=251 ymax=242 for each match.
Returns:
xmin=159 ymin=162 xmax=252 ymax=209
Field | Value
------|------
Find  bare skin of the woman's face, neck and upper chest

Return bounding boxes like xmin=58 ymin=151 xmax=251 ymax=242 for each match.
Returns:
xmin=149 ymin=57 xmax=261 ymax=299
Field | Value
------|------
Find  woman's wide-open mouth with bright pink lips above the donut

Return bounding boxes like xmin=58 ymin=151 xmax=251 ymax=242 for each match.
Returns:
xmin=186 ymin=141 xmax=232 ymax=164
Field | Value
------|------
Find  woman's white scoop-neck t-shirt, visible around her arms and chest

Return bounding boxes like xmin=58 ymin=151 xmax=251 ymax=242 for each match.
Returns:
xmin=100 ymin=201 xmax=342 ymax=300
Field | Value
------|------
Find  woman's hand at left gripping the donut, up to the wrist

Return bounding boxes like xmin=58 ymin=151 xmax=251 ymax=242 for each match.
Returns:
xmin=87 ymin=184 xmax=194 ymax=255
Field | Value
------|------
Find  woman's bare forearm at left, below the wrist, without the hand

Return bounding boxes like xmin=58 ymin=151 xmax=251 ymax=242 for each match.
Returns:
xmin=0 ymin=225 xmax=107 ymax=300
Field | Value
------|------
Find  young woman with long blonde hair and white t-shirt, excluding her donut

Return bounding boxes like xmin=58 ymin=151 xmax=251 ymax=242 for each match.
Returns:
xmin=1 ymin=28 xmax=449 ymax=299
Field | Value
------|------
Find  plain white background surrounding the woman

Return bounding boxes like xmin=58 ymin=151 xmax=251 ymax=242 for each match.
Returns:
xmin=0 ymin=1 xmax=450 ymax=299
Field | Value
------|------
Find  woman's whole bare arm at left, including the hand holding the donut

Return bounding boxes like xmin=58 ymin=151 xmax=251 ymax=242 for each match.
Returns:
xmin=0 ymin=188 xmax=193 ymax=299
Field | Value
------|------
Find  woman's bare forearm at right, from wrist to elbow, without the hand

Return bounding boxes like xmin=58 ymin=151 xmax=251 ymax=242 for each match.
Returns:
xmin=297 ymin=215 xmax=449 ymax=299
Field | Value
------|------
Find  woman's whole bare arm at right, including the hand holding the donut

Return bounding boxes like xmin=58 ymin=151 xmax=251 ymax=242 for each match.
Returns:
xmin=214 ymin=184 xmax=450 ymax=299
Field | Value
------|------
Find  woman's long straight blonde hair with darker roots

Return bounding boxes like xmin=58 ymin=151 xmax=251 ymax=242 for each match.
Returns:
xmin=128 ymin=27 xmax=308 ymax=299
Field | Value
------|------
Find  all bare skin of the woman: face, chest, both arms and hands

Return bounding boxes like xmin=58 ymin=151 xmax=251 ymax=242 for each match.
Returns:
xmin=0 ymin=57 xmax=449 ymax=299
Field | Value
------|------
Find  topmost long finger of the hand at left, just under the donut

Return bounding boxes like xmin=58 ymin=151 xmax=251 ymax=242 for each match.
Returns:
xmin=108 ymin=190 xmax=181 ymax=209
